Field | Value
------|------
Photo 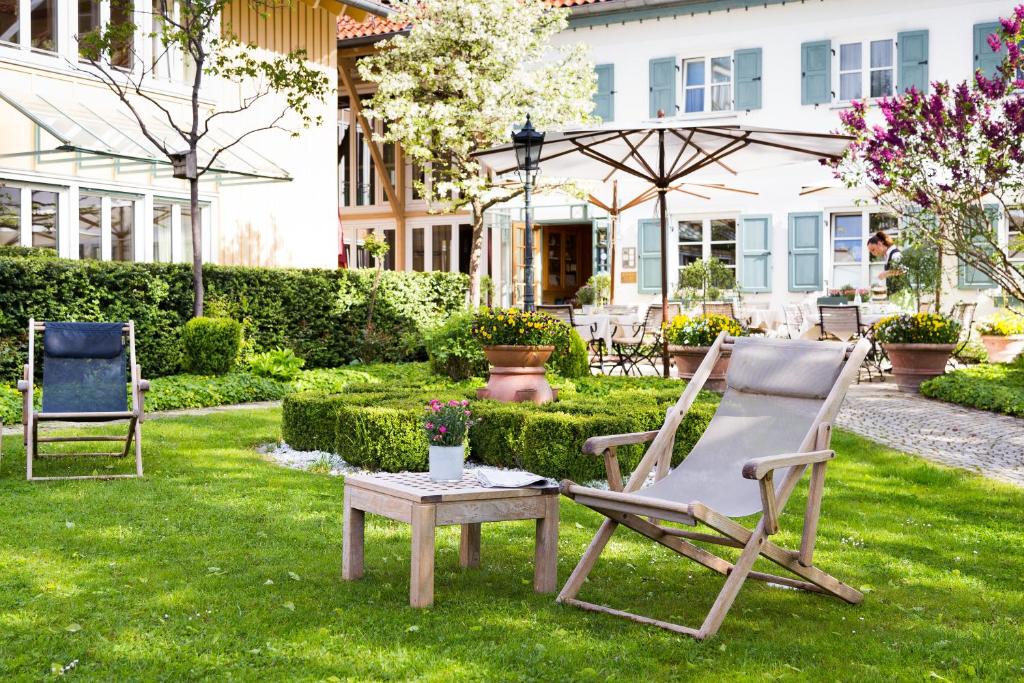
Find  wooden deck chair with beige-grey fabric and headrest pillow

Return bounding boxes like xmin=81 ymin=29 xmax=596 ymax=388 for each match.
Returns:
xmin=558 ymin=333 xmax=870 ymax=639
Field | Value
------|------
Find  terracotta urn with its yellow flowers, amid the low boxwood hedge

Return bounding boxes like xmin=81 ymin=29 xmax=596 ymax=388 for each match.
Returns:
xmin=473 ymin=308 xmax=569 ymax=403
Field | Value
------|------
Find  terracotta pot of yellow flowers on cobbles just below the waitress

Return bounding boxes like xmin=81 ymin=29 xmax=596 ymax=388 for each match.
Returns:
xmin=874 ymin=313 xmax=961 ymax=392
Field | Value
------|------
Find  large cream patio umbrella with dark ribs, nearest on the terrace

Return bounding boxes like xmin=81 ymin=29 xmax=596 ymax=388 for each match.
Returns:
xmin=476 ymin=122 xmax=852 ymax=377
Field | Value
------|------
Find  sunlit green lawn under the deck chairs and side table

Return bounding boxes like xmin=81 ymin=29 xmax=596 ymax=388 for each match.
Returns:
xmin=0 ymin=410 xmax=1024 ymax=681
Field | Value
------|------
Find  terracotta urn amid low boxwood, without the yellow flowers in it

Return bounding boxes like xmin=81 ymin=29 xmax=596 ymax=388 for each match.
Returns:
xmin=476 ymin=345 xmax=557 ymax=404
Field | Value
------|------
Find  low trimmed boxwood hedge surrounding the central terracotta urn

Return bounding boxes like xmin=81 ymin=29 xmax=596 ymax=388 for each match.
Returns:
xmin=282 ymin=374 xmax=718 ymax=481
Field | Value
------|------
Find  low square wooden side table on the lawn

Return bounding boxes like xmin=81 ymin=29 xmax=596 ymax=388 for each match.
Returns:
xmin=341 ymin=472 xmax=558 ymax=607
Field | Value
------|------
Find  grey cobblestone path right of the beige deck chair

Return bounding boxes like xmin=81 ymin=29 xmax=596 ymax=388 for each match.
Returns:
xmin=838 ymin=383 xmax=1024 ymax=486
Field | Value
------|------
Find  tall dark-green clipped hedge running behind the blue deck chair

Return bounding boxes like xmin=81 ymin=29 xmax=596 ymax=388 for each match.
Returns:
xmin=0 ymin=251 xmax=467 ymax=384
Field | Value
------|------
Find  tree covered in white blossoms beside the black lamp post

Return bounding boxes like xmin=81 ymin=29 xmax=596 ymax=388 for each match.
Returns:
xmin=358 ymin=0 xmax=596 ymax=307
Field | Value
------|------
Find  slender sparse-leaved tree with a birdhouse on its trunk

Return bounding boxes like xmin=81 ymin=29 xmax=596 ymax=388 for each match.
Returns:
xmin=78 ymin=0 xmax=331 ymax=316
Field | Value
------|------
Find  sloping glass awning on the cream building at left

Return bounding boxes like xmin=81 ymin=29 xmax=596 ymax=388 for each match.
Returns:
xmin=0 ymin=90 xmax=292 ymax=182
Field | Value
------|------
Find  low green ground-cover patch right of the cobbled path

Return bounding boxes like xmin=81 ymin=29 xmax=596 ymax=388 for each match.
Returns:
xmin=921 ymin=364 xmax=1024 ymax=417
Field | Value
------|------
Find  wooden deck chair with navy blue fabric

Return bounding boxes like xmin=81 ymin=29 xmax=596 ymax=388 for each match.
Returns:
xmin=17 ymin=319 xmax=150 ymax=481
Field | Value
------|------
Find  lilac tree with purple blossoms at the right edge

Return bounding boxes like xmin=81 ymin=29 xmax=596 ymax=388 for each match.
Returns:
xmin=836 ymin=5 xmax=1024 ymax=307
